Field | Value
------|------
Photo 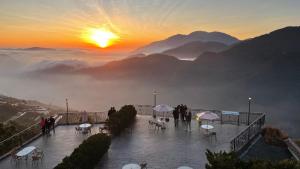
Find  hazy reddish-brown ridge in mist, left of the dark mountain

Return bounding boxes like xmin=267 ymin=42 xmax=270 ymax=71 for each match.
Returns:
xmin=80 ymin=54 xmax=187 ymax=82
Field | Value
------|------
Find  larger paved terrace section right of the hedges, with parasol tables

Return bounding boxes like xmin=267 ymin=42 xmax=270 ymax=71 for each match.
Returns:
xmin=96 ymin=116 xmax=246 ymax=169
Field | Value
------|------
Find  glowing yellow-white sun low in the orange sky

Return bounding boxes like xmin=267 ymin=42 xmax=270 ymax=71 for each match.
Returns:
xmin=82 ymin=28 xmax=120 ymax=48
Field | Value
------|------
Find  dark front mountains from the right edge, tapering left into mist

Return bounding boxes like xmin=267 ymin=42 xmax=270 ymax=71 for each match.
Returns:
xmin=72 ymin=27 xmax=300 ymax=111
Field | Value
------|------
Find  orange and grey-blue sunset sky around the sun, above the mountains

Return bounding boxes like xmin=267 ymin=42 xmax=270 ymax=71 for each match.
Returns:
xmin=0 ymin=0 xmax=300 ymax=50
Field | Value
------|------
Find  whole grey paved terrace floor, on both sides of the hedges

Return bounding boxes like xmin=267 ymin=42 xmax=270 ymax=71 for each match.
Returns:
xmin=0 ymin=116 xmax=245 ymax=169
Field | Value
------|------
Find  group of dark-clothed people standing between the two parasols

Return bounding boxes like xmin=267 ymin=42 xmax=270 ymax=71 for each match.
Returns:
xmin=173 ymin=104 xmax=192 ymax=131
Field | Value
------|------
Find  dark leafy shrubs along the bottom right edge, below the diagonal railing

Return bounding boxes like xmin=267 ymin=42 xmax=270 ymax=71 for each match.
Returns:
xmin=205 ymin=150 xmax=300 ymax=169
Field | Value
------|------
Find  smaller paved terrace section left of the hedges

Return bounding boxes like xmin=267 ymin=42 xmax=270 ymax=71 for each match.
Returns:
xmin=0 ymin=125 xmax=99 ymax=169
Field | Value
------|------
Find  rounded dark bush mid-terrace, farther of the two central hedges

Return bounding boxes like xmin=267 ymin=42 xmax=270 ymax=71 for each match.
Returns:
xmin=107 ymin=105 xmax=137 ymax=135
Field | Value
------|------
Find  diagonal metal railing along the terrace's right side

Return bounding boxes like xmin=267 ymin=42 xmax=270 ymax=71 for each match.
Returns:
xmin=230 ymin=114 xmax=266 ymax=152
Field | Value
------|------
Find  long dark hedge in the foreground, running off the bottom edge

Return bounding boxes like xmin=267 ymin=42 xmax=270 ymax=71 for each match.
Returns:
xmin=55 ymin=133 xmax=111 ymax=169
